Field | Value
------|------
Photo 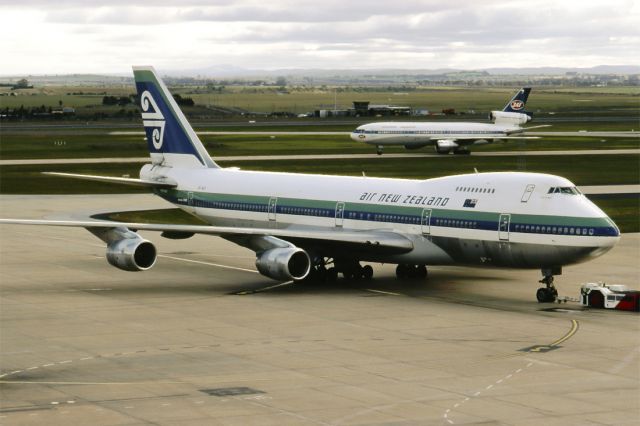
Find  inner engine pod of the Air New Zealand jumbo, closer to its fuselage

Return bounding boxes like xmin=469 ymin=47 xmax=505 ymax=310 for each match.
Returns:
xmin=256 ymin=247 xmax=311 ymax=280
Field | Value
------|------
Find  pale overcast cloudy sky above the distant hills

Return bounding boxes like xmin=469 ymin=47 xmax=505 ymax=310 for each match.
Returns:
xmin=0 ymin=0 xmax=640 ymax=75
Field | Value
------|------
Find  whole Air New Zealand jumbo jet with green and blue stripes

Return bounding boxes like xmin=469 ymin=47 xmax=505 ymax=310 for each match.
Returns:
xmin=0 ymin=67 xmax=620 ymax=302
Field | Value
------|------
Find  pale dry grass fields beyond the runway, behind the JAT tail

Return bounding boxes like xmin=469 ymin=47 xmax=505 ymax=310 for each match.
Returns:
xmin=0 ymin=85 xmax=640 ymax=115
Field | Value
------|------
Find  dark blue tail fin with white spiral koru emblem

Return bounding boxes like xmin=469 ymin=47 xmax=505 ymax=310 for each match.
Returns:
xmin=133 ymin=66 xmax=219 ymax=168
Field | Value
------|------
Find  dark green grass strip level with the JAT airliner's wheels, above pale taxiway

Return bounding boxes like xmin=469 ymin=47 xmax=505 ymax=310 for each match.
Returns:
xmin=0 ymin=129 xmax=640 ymax=160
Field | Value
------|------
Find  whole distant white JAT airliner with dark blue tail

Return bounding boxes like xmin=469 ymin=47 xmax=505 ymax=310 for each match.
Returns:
xmin=351 ymin=87 xmax=546 ymax=155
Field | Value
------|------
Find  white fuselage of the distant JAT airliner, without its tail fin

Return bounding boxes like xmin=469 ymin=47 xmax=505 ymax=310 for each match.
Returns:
xmin=351 ymin=122 xmax=522 ymax=146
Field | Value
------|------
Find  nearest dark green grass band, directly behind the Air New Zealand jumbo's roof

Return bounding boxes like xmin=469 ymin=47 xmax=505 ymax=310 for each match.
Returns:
xmin=0 ymin=155 xmax=640 ymax=194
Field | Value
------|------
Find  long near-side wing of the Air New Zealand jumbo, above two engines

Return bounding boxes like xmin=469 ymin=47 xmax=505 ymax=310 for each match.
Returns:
xmin=0 ymin=219 xmax=413 ymax=254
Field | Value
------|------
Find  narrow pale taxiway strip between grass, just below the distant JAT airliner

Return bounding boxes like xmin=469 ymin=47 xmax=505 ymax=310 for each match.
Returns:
xmin=0 ymin=148 xmax=640 ymax=166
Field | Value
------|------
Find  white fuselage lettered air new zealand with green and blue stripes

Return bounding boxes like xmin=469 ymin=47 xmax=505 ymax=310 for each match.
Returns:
xmin=141 ymin=166 xmax=619 ymax=268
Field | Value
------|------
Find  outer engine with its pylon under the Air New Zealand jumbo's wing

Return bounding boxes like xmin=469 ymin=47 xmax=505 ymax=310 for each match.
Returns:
xmin=87 ymin=228 xmax=158 ymax=272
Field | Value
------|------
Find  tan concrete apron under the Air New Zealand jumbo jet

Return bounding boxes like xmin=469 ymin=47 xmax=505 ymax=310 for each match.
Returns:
xmin=0 ymin=195 xmax=640 ymax=425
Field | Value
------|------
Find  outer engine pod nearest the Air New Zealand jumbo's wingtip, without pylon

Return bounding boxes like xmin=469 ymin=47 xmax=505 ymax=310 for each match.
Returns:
xmin=107 ymin=234 xmax=158 ymax=272
